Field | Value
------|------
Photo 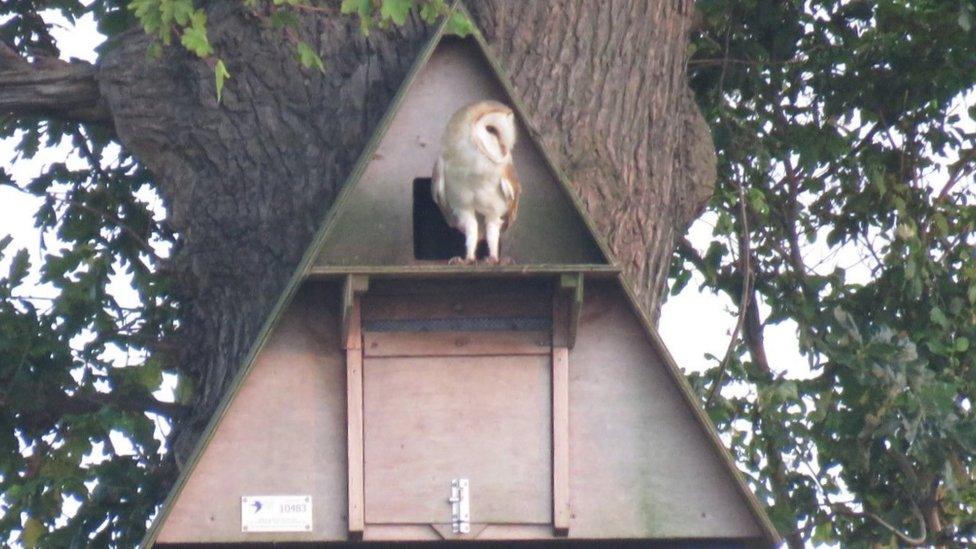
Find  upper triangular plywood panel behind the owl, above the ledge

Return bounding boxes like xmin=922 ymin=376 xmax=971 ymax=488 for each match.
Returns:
xmin=306 ymin=17 xmax=613 ymax=275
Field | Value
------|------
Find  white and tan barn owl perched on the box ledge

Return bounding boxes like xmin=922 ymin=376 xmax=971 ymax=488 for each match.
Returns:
xmin=432 ymin=101 xmax=521 ymax=263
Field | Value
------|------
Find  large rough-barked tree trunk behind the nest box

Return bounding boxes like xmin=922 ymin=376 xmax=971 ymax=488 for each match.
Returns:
xmin=84 ymin=0 xmax=714 ymax=462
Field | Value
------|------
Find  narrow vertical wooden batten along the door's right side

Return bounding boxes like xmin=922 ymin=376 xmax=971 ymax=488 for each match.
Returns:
xmin=552 ymin=347 xmax=570 ymax=536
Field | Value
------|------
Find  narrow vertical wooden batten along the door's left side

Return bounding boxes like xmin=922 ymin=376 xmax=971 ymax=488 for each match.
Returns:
xmin=346 ymin=349 xmax=366 ymax=539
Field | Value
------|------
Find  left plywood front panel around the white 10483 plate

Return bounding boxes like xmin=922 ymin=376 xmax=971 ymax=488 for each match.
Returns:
xmin=158 ymin=284 xmax=347 ymax=543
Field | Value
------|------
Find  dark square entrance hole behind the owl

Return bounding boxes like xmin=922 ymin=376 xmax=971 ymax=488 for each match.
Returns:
xmin=413 ymin=177 xmax=488 ymax=261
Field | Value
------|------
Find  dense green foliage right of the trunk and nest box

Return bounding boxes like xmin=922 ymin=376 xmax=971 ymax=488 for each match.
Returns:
xmin=673 ymin=0 xmax=976 ymax=546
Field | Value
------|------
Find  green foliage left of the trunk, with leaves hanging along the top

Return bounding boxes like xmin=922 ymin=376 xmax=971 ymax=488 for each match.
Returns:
xmin=0 ymin=0 xmax=470 ymax=547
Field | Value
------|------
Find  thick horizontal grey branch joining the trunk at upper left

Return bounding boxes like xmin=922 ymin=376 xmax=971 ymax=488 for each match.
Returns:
xmin=0 ymin=42 xmax=111 ymax=122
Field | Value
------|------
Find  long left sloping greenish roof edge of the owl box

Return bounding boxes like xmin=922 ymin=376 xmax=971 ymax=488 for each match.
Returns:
xmin=139 ymin=7 xmax=460 ymax=548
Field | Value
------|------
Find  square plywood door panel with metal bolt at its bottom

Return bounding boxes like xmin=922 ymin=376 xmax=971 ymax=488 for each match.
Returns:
xmin=363 ymin=355 xmax=552 ymax=531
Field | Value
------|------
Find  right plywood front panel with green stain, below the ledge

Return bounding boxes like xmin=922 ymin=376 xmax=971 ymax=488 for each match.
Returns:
xmin=569 ymin=281 xmax=760 ymax=538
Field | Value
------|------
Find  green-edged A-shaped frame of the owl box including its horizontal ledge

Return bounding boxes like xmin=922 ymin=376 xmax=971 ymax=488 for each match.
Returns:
xmin=141 ymin=1 xmax=781 ymax=547
